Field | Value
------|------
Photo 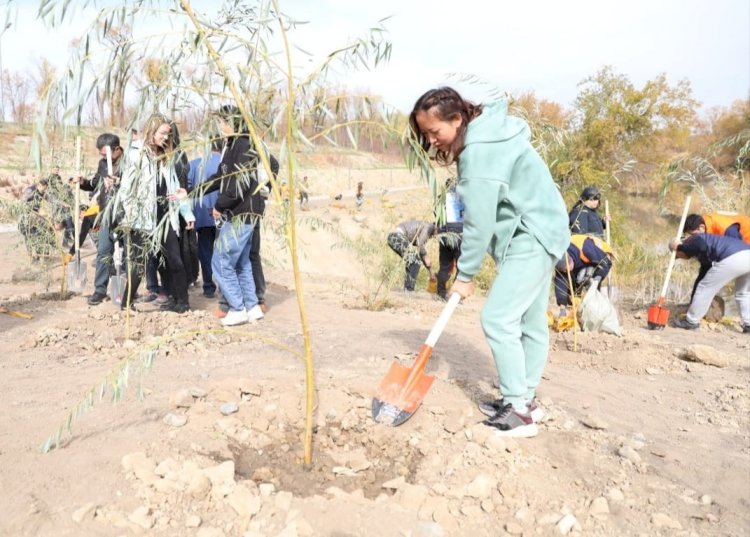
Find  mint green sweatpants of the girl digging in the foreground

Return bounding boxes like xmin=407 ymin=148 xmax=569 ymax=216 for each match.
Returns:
xmin=481 ymin=231 xmax=555 ymax=411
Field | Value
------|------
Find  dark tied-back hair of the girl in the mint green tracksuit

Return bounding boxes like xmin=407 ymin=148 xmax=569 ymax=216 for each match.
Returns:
xmin=409 ymin=87 xmax=482 ymax=165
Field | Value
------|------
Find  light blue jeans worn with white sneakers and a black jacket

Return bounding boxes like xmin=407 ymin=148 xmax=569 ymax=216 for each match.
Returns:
xmin=211 ymin=222 xmax=258 ymax=311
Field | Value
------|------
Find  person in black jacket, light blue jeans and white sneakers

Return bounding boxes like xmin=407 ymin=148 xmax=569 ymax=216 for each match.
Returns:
xmin=203 ymin=105 xmax=265 ymax=326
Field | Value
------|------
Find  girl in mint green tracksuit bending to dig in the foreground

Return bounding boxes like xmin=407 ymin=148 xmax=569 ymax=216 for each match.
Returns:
xmin=409 ymin=88 xmax=570 ymax=437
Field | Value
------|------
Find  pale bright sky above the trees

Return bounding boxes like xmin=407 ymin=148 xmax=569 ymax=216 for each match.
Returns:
xmin=0 ymin=0 xmax=750 ymax=111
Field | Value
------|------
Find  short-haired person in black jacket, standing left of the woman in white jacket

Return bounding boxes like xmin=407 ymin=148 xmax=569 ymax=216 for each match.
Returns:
xmin=69 ymin=132 xmax=123 ymax=306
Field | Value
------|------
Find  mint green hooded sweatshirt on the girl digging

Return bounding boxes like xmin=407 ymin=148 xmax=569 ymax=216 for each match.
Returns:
xmin=458 ymin=102 xmax=570 ymax=281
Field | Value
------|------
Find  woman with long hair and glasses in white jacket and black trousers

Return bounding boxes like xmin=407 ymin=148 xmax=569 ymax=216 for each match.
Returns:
xmin=118 ymin=114 xmax=195 ymax=313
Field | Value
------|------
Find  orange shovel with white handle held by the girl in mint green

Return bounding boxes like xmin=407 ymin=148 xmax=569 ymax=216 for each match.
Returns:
xmin=372 ymin=293 xmax=461 ymax=427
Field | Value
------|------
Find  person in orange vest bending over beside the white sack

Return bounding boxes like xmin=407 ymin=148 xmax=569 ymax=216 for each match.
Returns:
xmin=555 ymin=235 xmax=614 ymax=316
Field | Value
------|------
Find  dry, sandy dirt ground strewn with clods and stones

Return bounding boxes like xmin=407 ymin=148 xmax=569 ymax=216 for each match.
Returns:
xmin=0 ymin=189 xmax=750 ymax=537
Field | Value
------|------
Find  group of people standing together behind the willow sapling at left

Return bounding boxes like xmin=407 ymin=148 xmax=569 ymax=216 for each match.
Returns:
xmin=41 ymin=105 xmax=279 ymax=326
